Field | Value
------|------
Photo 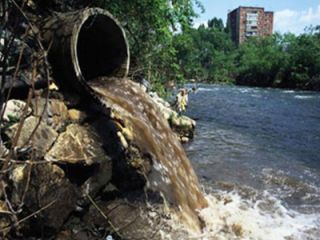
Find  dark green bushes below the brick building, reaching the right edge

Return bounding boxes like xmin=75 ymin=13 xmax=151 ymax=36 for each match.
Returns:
xmin=235 ymin=30 xmax=320 ymax=90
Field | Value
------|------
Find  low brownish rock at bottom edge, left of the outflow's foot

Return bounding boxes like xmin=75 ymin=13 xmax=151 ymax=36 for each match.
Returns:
xmin=82 ymin=199 xmax=188 ymax=240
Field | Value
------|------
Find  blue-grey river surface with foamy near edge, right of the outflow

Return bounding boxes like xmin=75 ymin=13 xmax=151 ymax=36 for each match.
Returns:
xmin=185 ymin=85 xmax=320 ymax=240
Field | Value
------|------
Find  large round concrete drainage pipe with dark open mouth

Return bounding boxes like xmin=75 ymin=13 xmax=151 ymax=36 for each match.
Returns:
xmin=40 ymin=8 xmax=130 ymax=91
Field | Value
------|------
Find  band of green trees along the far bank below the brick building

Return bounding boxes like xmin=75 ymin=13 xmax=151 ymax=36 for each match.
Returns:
xmin=175 ymin=21 xmax=320 ymax=90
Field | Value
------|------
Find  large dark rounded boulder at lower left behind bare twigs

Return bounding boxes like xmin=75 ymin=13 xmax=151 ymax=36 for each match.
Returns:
xmin=10 ymin=163 xmax=78 ymax=234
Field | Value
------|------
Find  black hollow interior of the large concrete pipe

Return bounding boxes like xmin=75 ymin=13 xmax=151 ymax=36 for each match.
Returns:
xmin=77 ymin=15 xmax=127 ymax=81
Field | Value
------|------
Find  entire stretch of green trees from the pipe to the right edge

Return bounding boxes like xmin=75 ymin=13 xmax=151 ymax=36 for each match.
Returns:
xmin=92 ymin=0 xmax=320 ymax=91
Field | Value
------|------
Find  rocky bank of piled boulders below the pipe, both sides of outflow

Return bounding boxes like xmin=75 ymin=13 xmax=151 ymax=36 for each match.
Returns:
xmin=0 ymin=81 xmax=196 ymax=239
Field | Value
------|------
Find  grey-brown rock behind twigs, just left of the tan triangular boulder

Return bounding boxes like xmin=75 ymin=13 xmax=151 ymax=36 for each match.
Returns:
xmin=5 ymin=116 xmax=58 ymax=158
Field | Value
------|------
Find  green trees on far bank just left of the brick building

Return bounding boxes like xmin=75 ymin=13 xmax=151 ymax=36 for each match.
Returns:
xmin=174 ymin=18 xmax=235 ymax=83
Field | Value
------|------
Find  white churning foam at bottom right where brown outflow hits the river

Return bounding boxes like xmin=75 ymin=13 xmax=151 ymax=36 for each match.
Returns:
xmin=165 ymin=191 xmax=320 ymax=240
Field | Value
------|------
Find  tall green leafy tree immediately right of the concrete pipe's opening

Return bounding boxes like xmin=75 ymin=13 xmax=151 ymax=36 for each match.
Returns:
xmin=98 ymin=0 xmax=201 ymax=89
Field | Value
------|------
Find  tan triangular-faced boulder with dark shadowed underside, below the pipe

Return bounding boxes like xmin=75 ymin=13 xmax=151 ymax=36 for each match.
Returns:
xmin=45 ymin=124 xmax=112 ymax=196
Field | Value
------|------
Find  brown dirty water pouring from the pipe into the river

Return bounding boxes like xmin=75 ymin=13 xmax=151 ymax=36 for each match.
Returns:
xmin=88 ymin=77 xmax=207 ymax=231
